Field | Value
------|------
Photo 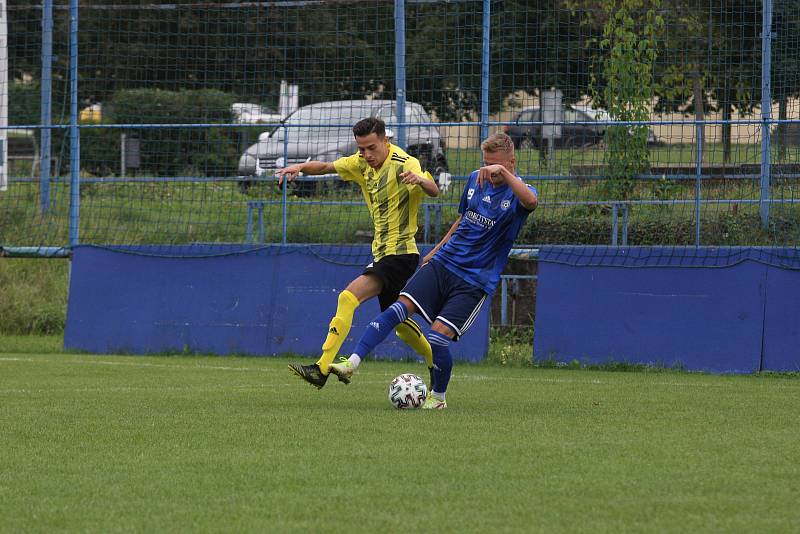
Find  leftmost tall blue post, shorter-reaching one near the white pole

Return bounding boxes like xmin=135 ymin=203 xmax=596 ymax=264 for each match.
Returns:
xmin=39 ymin=0 xmax=53 ymax=214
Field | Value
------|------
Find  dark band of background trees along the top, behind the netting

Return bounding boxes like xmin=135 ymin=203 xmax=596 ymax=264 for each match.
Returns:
xmin=8 ymin=0 xmax=800 ymax=134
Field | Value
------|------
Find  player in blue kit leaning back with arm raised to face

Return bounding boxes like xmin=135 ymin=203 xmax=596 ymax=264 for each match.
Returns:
xmin=330 ymin=133 xmax=538 ymax=409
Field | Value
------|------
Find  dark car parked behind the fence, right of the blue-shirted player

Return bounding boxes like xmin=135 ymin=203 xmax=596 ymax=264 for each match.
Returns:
xmin=505 ymin=107 xmax=656 ymax=148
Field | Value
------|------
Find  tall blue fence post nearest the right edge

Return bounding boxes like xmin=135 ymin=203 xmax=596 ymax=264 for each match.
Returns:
xmin=759 ymin=0 xmax=772 ymax=229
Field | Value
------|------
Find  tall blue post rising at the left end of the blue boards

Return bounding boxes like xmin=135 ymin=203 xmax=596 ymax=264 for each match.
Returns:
xmin=69 ymin=0 xmax=81 ymax=247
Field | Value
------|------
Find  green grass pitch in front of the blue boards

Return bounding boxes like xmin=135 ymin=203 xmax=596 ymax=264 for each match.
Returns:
xmin=0 ymin=351 xmax=800 ymax=532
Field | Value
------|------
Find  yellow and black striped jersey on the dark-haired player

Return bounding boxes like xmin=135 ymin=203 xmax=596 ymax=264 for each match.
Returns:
xmin=333 ymin=144 xmax=433 ymax=261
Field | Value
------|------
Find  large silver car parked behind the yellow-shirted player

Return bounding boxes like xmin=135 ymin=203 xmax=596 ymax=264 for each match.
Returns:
xmin=239 ymin=100 xmax=448 ymax=194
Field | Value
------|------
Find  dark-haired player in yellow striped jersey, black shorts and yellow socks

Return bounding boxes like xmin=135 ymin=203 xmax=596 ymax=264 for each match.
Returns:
xmin=275 ymin=117 xmax=439 ymax=389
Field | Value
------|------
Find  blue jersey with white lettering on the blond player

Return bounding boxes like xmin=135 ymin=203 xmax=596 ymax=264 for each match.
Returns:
xmin=433 ymin=171 xmax=536 ymax=294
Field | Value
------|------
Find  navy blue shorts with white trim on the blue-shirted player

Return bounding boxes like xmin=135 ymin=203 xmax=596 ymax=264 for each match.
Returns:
xmin=400 ymin=260 xmax=487 ymax=339
